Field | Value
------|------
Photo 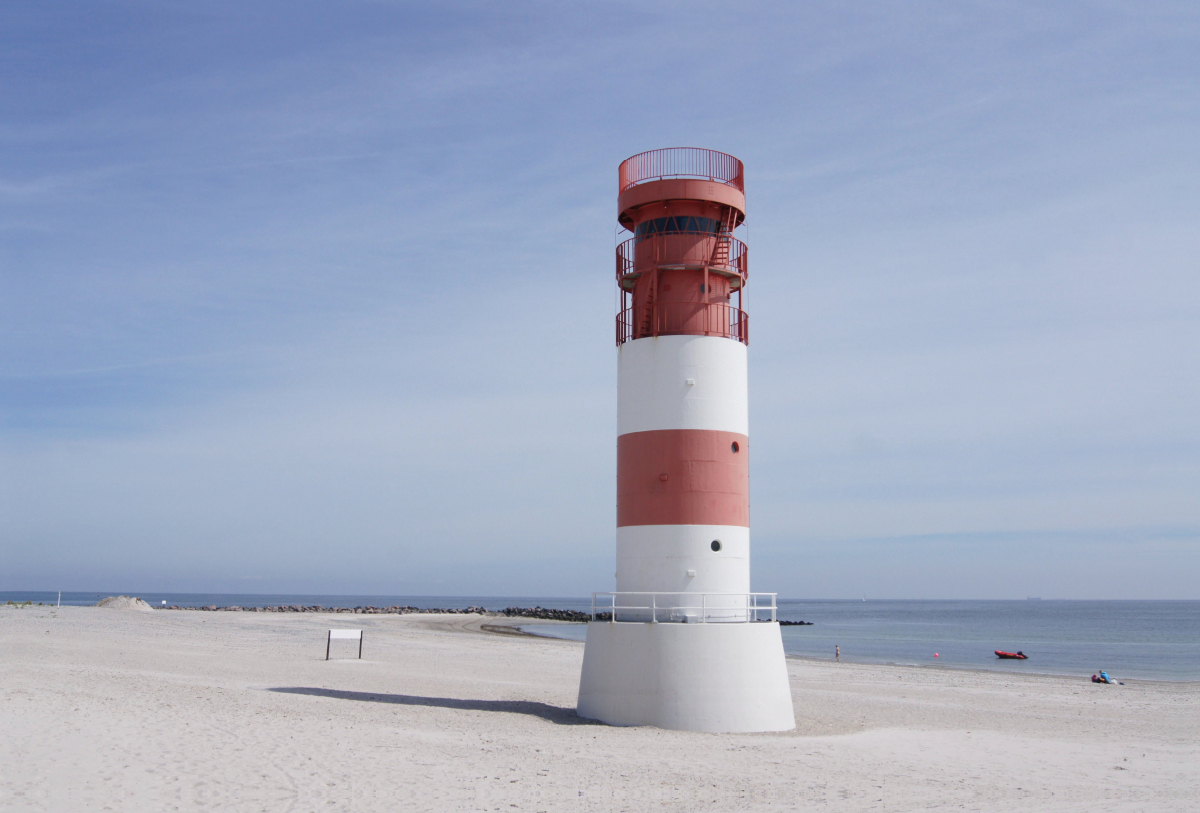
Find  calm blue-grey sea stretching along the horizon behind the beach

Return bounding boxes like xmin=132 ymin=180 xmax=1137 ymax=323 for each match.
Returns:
xmin=0 ymin=591 xmax=1200 ymax=681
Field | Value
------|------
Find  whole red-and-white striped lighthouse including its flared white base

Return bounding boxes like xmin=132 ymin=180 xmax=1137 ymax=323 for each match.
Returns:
xmin=578 ymin=147 xmax=796 ymax=731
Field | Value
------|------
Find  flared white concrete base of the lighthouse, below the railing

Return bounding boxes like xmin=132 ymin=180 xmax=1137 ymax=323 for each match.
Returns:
xmin=577 ymin=621 xmax=796 ymax=733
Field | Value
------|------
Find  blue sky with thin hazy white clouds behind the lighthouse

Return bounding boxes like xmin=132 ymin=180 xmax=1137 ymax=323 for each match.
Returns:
xmin=0 ymin=0 xmax=1200 ymax=598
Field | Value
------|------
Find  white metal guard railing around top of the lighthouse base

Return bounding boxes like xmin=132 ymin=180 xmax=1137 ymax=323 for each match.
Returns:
xmin=592 ymin=592 xmax=778 ymax=624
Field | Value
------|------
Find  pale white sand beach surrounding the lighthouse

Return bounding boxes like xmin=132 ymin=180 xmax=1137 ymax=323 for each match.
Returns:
xmin=0 ymin=607 xmax=1200 ymax=812
